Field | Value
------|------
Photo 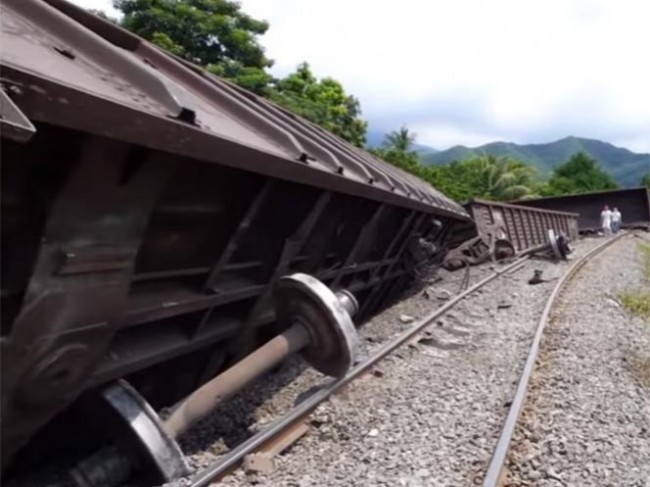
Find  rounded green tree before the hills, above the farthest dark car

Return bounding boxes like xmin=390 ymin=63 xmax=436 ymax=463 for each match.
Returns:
xmin=543 ymin=152 xmax=618 ymax=196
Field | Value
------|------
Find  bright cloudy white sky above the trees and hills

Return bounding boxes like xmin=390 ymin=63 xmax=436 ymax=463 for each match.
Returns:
xmin=73 ymin=0 xmax=650 ymax=152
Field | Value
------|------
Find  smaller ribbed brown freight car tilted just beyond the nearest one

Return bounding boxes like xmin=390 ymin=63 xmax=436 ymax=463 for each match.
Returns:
xmin=466 ymin=200 xmax=579 ymax=252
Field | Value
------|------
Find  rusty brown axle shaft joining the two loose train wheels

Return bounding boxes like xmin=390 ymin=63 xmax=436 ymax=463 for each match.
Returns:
xmin=164 ymin=324 xmax=309 ymax=438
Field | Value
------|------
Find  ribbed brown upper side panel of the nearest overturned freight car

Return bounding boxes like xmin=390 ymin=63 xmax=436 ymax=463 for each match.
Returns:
xmin=1 ymin=0 xmax=466 ymax=217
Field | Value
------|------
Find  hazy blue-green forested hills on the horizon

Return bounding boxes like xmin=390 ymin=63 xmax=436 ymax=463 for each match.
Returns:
xmin=422 ymin=137 xmax=650 ymax=187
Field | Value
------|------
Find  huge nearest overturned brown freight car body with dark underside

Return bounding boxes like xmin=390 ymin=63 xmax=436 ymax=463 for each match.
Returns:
xmin=0 ymin=0 xmax=469 ymax=475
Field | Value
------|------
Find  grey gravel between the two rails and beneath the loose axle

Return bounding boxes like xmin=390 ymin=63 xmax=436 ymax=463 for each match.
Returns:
xmin=183 ymin=235 xmax=636 ymax=486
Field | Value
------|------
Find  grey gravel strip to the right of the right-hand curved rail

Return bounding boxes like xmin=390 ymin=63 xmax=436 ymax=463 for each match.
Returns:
xmin=506 ymin=237 xmax=650 ymax=487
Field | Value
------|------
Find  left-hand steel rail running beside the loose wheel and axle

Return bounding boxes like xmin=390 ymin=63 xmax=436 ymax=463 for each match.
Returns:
xmin=190 ymin=256 xmax=530 ymax=487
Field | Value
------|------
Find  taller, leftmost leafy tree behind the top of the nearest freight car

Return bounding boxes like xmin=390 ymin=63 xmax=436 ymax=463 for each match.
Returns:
xmin=114 ymin=0 xmax=273 ymax=94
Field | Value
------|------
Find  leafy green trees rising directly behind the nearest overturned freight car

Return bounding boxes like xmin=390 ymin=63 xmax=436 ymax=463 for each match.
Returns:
xmin=114 ymin=0 xmax=368 ymax=143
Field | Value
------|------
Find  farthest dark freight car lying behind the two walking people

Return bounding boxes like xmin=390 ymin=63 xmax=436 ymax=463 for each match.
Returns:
xmin=512 ymin=188 xmax=650 ymax=233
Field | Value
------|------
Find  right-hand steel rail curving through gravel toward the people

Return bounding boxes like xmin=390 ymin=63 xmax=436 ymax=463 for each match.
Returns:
xmin=483 ymin=234 xmax=627 ymax=487
